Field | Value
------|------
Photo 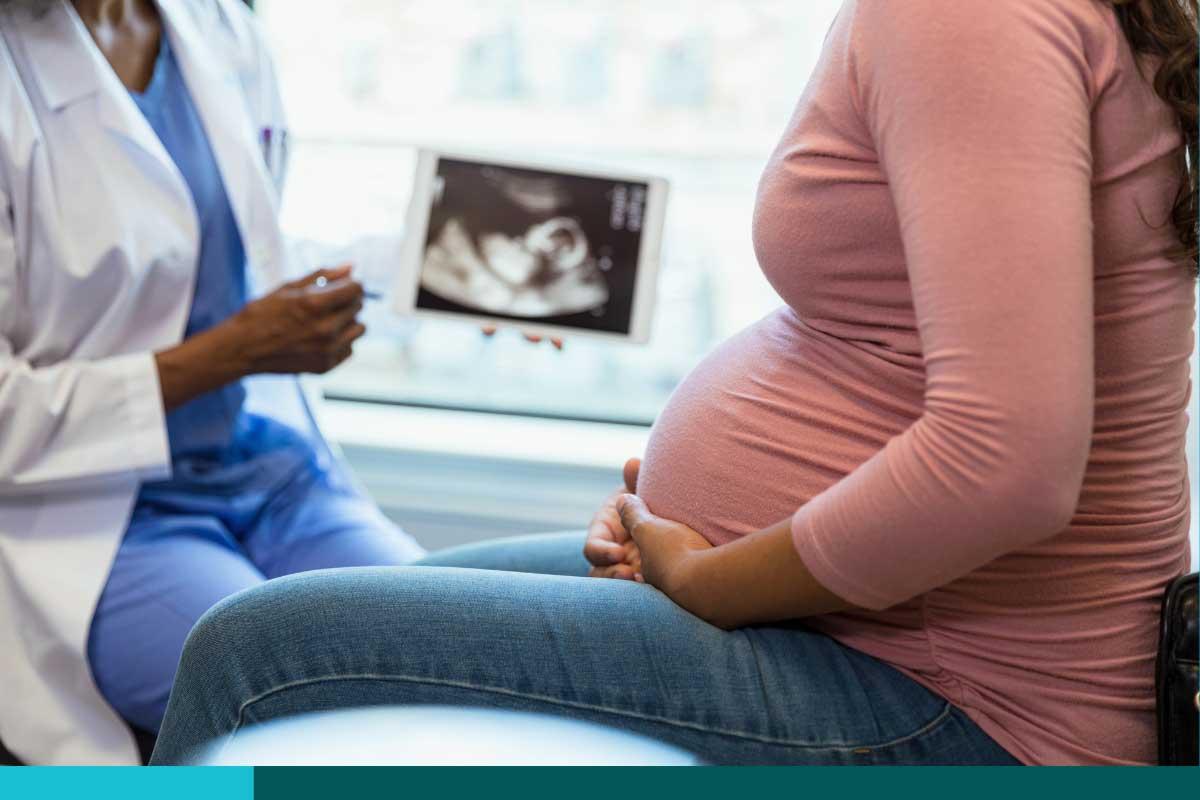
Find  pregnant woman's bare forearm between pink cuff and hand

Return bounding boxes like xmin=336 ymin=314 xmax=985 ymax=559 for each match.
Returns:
xmin=677 ymin=519 xmax=852 ymax=630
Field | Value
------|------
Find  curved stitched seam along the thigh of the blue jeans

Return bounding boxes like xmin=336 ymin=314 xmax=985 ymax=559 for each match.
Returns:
xmin=227 ymin=674 xmax=953 ymax=751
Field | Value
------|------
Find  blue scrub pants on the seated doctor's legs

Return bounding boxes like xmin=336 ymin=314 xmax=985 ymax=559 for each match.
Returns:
xmin=88 ymin=453 xmax=422 ymax=733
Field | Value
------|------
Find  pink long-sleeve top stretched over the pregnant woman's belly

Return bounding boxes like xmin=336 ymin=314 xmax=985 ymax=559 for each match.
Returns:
xmin=638 ymin=0 xmax=1195 ymax=764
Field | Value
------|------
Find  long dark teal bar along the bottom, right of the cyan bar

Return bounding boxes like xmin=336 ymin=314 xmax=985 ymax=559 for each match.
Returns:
xmin=254 ymin=766 xmax=1200 ymax=800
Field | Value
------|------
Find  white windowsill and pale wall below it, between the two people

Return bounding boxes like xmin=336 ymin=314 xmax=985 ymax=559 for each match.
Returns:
xmin=320 ymin=401 xmax=649 ymax=551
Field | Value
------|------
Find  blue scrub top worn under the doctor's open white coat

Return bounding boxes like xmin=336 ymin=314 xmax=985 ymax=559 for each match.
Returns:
xmin=130 ymin=34 xmax=316 ymax=501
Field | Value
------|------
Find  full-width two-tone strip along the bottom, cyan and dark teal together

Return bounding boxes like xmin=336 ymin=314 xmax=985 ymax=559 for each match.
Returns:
xmin=0 ymin=768 xmax=1200 ymax=800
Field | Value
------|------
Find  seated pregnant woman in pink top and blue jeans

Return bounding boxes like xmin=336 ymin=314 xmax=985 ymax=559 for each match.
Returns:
xmin=147 ymin=0 xmax=1196 ymax=764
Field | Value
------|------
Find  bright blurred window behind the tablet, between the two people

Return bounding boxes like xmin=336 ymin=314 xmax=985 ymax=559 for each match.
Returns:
xmin=256 ymin=0 xmax=841 ymax=422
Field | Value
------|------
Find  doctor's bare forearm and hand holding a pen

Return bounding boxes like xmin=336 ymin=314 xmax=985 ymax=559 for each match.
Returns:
xmin=155 ymin=266 xmax=366 ymax=411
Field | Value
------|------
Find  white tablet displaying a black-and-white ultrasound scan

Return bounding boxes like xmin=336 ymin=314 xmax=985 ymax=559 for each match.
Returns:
xmin=392 ymin=150 xmax=667 ymax=342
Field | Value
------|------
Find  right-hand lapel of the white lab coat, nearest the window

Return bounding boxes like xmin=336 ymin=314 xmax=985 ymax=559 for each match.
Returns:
xmin=158 ymin=0 xmax=286 ymax=287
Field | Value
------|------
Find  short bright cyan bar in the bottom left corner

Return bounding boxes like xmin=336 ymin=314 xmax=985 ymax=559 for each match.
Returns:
xmin=0 ymin=766 xmax=254 ymax=800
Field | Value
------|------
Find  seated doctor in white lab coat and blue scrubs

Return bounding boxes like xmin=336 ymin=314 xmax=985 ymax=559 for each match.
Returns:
xmin=0 ymin=0 xmax=421 ymax=764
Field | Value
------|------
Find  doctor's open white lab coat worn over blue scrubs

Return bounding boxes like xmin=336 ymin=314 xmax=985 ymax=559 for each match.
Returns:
xmin=0 ymin=0 xmax=348 ymax=764
